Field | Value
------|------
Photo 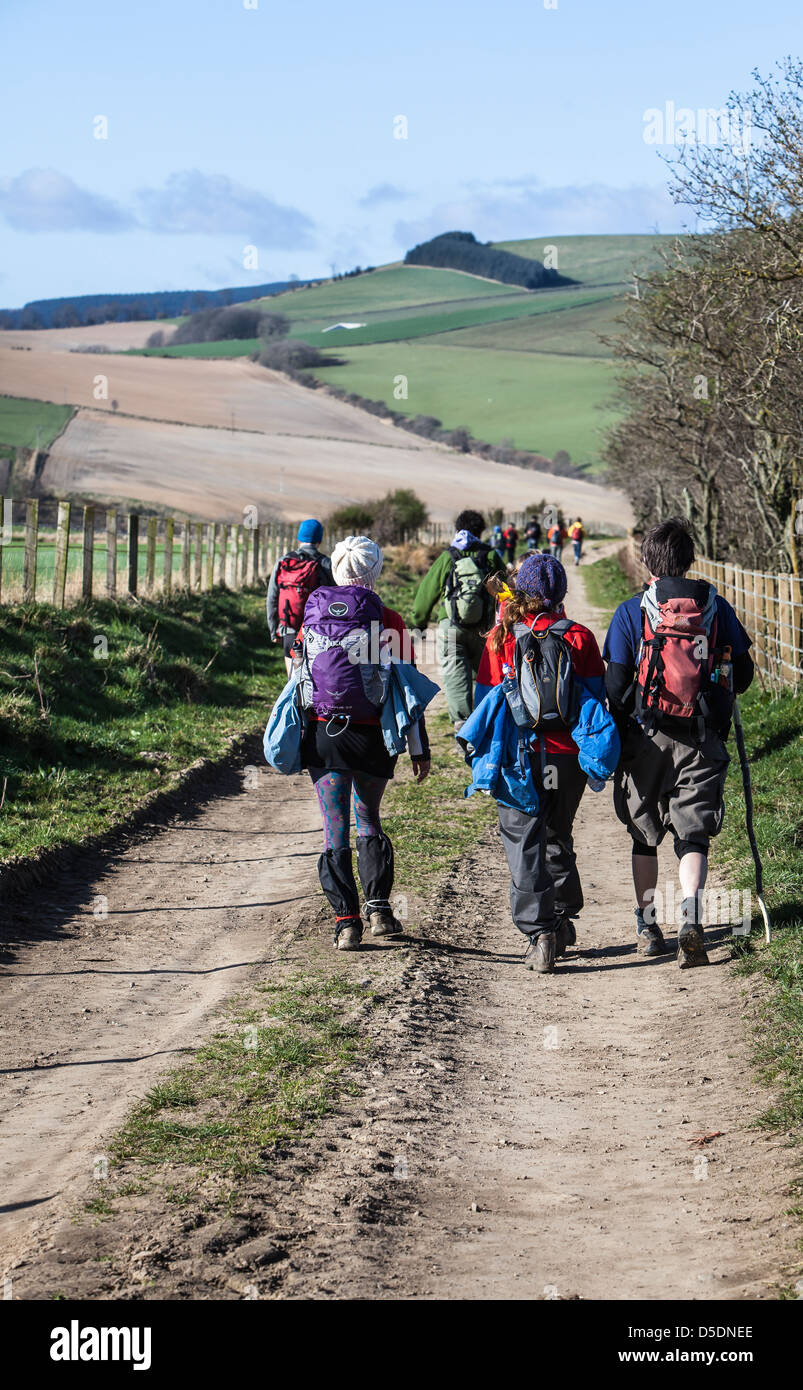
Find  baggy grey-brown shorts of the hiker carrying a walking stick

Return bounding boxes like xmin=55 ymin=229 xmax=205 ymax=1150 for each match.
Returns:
xmin=614 ymin=724 xmax=731 ymax=849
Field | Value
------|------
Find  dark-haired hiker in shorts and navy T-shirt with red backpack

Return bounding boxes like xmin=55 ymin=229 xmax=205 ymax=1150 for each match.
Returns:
xmin=603 ymin=518 xmax=753 ymax=969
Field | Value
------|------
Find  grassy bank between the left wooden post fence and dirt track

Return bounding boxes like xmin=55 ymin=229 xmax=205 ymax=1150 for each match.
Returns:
xmin=0 ymin=589 xmax=285 ymax=865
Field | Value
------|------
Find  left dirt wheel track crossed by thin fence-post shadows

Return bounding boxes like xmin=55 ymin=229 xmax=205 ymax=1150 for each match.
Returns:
xmin=0 ymin=748 xmax=320 ymax=1265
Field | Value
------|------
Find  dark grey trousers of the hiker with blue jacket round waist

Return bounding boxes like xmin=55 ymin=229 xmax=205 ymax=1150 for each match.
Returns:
xmin=499 ymin=753 xmax=586 ymax=935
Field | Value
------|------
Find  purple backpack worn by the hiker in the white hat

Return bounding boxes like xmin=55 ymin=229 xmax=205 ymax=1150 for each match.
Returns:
xmin=300 ymin=584 xmax=388 ymax=723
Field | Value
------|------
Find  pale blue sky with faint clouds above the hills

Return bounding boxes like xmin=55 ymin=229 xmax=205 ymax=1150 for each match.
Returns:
xmin=0 ymin=0 xmax=803 ymax=307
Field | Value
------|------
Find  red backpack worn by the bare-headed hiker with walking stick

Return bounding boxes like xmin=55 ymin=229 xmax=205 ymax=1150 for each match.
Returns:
xmin=636 ymin=578 xmax=718 ymax=727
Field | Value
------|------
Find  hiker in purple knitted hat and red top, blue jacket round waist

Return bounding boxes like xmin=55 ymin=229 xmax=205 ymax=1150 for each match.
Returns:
xmin=460 ymin=550 xmax=620 ymax=974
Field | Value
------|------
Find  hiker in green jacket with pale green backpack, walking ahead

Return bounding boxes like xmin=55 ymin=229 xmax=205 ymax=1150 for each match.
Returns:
xmin=410 ymin=510 xmax=504 ymax=733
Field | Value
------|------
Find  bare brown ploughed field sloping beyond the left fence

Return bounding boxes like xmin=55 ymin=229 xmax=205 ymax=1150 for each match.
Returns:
xmin=0 ymin=324 xmax=632 ymax=527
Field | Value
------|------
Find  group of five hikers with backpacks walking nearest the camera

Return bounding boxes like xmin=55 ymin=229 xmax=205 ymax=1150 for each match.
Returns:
xmin=265 ymin=510 xmax=753 ymax=973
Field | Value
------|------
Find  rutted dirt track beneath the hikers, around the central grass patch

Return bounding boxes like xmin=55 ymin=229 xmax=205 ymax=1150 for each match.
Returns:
xmin=0 ymin=547 xmax=796 ymax=1300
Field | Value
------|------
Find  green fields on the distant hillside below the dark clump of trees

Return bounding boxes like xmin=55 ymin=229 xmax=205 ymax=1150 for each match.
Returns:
xmin=125 ymin=236 xmax=674 ymax=471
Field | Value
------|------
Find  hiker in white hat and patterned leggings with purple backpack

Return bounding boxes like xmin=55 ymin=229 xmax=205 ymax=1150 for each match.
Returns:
xmin=293 ymin=535 xmax=436 ymax=951
